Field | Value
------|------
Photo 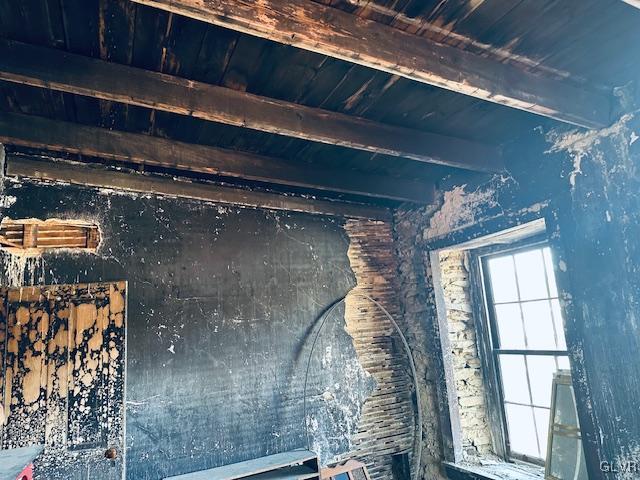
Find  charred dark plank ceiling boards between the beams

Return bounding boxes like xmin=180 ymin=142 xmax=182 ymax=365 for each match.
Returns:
xmin=0 ymin=0 xmax=640 ymax=201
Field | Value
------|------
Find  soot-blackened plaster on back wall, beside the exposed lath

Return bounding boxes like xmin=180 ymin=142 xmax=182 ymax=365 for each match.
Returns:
xmin=1 ymin=177 xmax=373 ymax=480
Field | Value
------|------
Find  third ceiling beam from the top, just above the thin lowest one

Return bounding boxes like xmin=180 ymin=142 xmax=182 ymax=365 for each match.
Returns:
xmin=0 ymin=112 xmax=435 ymax=203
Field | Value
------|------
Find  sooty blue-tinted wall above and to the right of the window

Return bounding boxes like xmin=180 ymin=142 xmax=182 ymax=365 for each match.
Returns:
xmin=416 ymin=112 xmax=640 ymax=480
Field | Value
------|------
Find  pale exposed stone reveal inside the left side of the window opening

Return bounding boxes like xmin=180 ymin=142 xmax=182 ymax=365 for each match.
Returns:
xmin=440 ymin=250 xmax=492 ymax=460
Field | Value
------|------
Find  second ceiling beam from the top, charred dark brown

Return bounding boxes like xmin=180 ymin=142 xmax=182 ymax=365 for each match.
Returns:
xmin=0 ymin=40 xmax=503 ymax=172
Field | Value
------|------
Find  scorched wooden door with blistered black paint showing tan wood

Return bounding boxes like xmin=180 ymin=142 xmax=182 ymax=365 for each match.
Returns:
xmin=0 ymin=282 xmax=126 ymax=480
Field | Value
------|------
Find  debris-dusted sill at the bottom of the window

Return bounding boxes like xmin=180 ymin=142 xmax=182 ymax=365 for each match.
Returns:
xmin=443 ymin=462 xmax=544 ymax=480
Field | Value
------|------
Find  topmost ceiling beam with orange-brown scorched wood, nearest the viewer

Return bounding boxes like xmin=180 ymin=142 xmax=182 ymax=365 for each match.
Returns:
xmin=133 ymin=0 xmax=612 ymax=128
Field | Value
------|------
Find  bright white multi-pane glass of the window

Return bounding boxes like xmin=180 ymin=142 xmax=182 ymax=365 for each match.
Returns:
xmin=484 ymin=245 xmax=569 ymax=460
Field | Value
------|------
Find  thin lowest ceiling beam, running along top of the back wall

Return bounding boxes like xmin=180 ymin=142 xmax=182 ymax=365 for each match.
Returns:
xmin=6 ymin=155 xmax=391 ymax=220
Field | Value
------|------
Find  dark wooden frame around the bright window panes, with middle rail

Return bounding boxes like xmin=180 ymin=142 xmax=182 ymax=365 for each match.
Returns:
xmin=469 ymin=238 xmax=569 ymax=466
